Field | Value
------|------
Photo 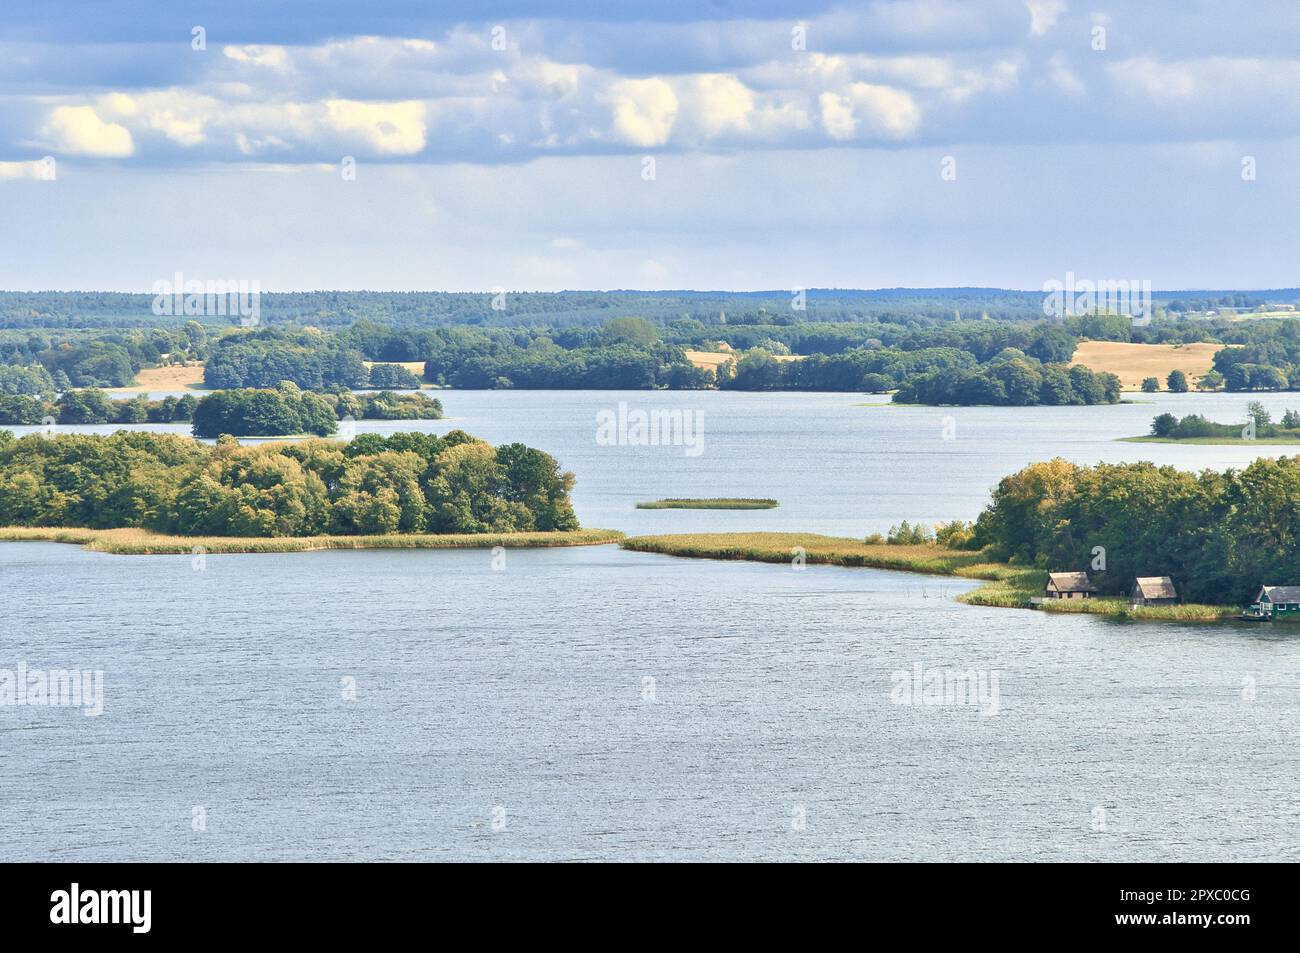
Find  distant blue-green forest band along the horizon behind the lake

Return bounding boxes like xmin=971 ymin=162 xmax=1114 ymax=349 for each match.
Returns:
xmin=12 ymin=289 xmax=1300 ymax=404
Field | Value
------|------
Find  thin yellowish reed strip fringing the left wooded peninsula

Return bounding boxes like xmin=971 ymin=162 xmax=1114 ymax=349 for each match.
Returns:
xmin=0 ymin=527 xmax=623 ymax=555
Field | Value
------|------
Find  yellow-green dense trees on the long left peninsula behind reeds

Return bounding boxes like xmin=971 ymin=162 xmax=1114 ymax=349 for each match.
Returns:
xmin=0 ymin=430 xmax=577 ymax=537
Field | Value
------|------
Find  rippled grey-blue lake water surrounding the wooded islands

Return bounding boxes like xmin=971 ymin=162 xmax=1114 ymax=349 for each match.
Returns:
xmin=0 ymin=391 xmax=1300 ymax=861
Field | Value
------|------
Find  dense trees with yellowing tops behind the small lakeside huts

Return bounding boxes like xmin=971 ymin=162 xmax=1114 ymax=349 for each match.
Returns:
xmin=974 ymin=458 xmax=1300 ymax=603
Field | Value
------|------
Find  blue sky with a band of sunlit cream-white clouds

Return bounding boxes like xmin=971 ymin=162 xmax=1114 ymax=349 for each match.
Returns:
xmin=0 ymin=0 xmax=1300 ymax=291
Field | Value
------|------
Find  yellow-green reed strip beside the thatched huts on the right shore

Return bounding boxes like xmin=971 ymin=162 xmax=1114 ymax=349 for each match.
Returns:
xmin=619 ymin=533 xmax=1240 ymax=621
